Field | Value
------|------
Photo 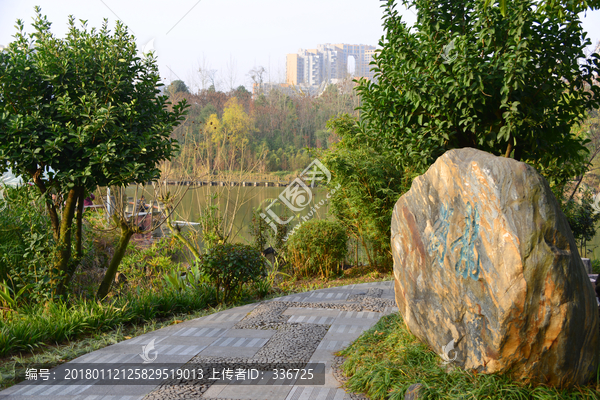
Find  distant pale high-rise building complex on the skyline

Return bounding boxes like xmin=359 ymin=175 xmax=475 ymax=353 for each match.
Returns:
xmin=286 ymin=43 xmax=375 ymax=86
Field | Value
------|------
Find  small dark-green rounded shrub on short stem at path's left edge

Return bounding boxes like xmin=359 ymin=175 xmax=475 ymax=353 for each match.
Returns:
xmin=200 ymin=243 xmax=266 ymax=303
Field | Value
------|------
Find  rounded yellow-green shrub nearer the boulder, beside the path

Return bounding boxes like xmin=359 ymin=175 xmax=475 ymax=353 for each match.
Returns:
xmin=287 ymin=219 xmax=348 ymax=277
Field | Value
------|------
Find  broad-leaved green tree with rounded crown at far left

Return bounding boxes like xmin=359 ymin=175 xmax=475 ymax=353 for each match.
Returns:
xmin=0 ymin=7 xmax=186 ymax=296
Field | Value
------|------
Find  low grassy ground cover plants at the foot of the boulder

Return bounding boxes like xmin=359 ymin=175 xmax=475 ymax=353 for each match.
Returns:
xmin=338 ymin=313 xmax=600 ymax=400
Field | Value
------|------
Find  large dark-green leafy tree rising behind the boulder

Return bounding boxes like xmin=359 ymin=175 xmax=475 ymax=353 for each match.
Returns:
xmin=358 ymin=0 xmax=600 ymax=192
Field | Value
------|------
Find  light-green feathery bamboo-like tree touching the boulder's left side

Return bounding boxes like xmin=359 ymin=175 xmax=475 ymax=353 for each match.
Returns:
xmin=319 ymin=114 xmax=410 ymax=270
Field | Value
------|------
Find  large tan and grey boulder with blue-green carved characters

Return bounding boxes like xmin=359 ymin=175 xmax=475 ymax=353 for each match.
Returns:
xmin=392 ymin=148 xmax=599 ymax=386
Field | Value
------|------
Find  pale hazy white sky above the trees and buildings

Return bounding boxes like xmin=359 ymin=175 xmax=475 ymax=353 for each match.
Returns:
xmin=0 ymin=0 xmax=600 ymax=90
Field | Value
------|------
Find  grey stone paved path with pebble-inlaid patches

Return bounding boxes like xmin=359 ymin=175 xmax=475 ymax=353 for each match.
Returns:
xmin=0 ymin=281 xmax=398 ymax=400
